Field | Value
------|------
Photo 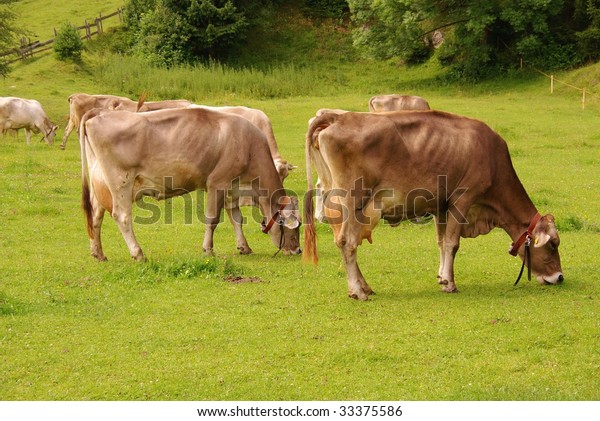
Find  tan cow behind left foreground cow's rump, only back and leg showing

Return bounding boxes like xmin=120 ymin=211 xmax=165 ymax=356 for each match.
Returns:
xmin=60 ymin=93 xmax=191 ymax=149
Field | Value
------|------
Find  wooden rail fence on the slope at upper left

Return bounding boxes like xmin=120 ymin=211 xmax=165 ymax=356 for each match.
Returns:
xmin=0 ymin=8 xmax=123 ymax=64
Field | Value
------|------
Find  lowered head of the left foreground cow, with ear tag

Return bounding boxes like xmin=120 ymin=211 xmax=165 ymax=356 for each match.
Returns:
xmin=268 ymin=197 xmax=302 ymax=256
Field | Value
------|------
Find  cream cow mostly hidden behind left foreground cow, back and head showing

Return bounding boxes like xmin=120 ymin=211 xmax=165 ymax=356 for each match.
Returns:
xmin=190 ymin=104 xmax=297 ymax=183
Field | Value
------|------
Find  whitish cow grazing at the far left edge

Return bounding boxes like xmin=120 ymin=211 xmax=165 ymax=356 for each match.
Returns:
xmin=0 ymin=97 xmax=58 ymax=145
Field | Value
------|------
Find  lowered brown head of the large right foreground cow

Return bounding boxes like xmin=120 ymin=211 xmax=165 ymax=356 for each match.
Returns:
xmin=519 ymin=215 xmax=563 ymax=284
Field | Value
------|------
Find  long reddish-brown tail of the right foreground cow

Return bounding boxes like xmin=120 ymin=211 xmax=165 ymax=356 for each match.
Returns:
xmin=302 ymin=113 xmax=339 ymax=265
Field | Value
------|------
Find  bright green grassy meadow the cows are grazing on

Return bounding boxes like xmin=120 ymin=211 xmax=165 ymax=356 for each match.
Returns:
xmin=0 ymin=0 xmax=600 ymax=400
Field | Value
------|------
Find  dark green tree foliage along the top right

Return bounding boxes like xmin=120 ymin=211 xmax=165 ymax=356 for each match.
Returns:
xmin=349 ymin=0 xmax=600 ymax=80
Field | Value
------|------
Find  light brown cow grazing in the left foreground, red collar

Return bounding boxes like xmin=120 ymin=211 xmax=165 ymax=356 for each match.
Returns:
xmin=79 ymin=108 xmax=301 ymax=261
